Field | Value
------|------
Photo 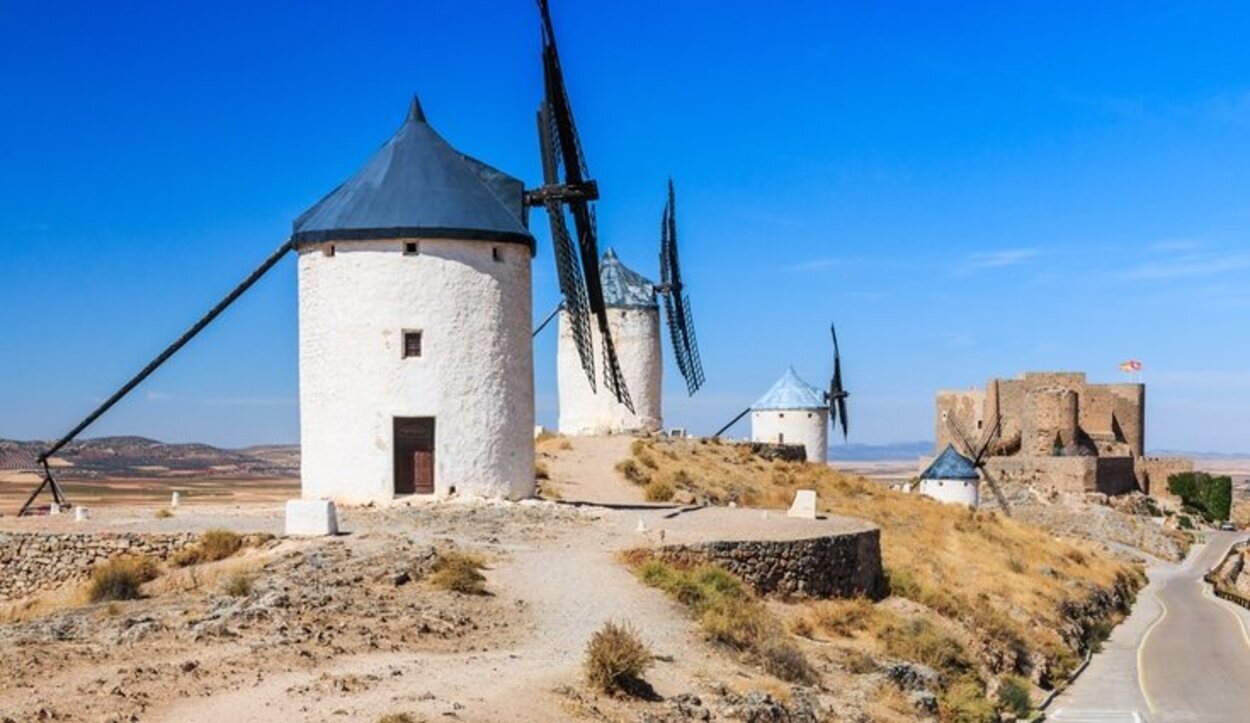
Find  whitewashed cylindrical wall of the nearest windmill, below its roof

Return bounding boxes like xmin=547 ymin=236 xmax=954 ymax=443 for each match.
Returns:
xmin=299 ymin=239 xmax=534 ymax=504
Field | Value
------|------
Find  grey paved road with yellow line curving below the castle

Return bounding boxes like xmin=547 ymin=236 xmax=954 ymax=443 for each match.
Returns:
xmin=1049 ymin=533 xmax=1250 ymax=723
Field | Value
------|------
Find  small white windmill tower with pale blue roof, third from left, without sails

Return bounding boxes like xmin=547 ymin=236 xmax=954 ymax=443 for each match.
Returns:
xmin=751 ymin=367 xmax=829 ymax=464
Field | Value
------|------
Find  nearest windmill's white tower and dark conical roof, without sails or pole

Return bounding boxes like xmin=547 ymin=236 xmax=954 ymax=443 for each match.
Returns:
xmin=293 ymin=99 xmax=534 ymax=504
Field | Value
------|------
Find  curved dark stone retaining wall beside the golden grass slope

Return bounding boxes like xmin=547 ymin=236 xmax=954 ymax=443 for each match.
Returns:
xmin=658 ymin=529 xmax=886 ymax=599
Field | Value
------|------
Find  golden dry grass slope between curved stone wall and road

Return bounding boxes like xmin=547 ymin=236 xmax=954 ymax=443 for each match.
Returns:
xmin=623 ymin=440 xmax=1145 ymax=720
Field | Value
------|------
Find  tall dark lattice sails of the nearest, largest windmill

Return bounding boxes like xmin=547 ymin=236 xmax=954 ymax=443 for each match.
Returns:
xmin=525 ymin=0 xmax=634 ymax=412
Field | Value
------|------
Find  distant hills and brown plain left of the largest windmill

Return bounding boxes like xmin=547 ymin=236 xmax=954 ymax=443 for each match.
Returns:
xmin=0 ymin=437 xmax=300 ymax=479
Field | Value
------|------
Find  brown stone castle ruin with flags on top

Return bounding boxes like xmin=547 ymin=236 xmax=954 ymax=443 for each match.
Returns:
xmin=934 ymin=372 xmax=1193 ymax=497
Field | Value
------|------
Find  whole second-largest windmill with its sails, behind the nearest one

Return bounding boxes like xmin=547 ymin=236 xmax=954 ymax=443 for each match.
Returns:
xmin=552 ymin=180 xmax=704 ymax=435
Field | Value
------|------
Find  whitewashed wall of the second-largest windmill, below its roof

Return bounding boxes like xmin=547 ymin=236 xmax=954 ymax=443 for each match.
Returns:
xmin=556 ymin=309 xmax=664 ymax=435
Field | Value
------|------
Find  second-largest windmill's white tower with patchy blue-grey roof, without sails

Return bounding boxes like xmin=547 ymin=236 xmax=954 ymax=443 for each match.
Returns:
xmin=556 ymin=249 xmax=664 ymax=435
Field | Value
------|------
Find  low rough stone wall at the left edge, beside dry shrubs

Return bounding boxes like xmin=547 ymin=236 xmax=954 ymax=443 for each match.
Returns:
xmin=0 ymin=525 xmax=198 ymax=600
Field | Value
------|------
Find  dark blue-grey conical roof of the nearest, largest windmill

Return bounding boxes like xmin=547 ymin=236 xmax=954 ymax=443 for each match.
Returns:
xmin=291 ymin=98 xmax=534 ymax=249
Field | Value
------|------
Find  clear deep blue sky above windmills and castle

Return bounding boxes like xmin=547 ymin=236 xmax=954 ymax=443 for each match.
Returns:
xmin=0 ymin=0 xmax=1250 ymax=450
